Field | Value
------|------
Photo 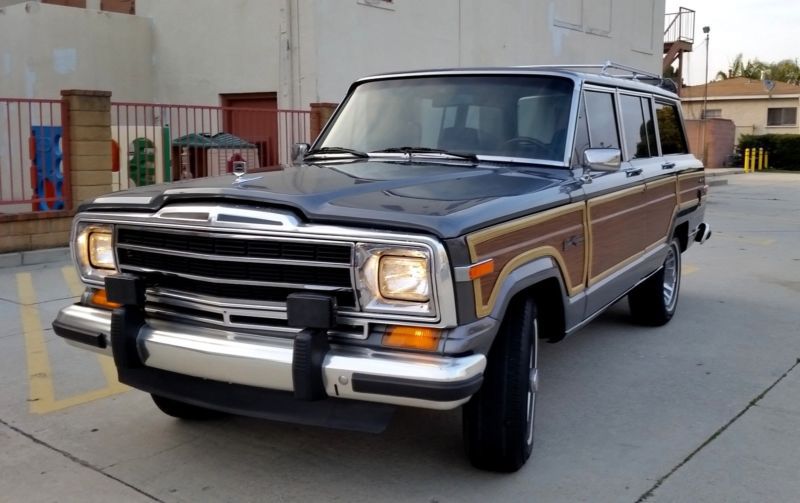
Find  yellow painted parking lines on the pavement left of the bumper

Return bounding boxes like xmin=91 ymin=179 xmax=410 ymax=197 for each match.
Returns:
xmin=16 ymin=274 xmax=129 ymax=414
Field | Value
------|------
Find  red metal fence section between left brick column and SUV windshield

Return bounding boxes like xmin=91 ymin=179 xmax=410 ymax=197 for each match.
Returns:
xmin=111 ymin=102 xmax=311 ymax=190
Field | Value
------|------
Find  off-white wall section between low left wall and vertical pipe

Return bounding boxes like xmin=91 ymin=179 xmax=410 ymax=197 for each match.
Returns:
xmin=136 ymin=0 xmax=283 ymax=105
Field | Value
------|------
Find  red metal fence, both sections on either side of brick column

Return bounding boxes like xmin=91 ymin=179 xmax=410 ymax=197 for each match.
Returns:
xmin=0 ymin=98 xmax=312 ymax=215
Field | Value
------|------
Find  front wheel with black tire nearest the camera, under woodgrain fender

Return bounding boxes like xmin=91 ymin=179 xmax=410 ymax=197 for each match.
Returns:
xmin=463 ymin=297 xmax=539 ymax=472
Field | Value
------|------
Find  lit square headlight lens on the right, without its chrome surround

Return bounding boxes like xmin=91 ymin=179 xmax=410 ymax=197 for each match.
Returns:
xmin=378 ymin=255 xmax=431 ymax=302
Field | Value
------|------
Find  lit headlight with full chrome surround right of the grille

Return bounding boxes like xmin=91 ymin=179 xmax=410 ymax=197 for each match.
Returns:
xmin=356 ymin=243 xmax=436 ymax=316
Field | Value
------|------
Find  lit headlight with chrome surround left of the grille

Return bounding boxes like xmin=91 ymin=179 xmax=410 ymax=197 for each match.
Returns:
xmin=73 ymin=222 xmax=117 ymax=283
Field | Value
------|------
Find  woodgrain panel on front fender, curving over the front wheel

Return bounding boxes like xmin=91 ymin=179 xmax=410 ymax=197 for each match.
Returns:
xmin=467 ymin=203 xmax=587 ymax=316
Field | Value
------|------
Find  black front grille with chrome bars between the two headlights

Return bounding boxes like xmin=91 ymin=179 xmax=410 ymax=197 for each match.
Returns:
xmin=116 ymin=226 xmax=356 ymax=314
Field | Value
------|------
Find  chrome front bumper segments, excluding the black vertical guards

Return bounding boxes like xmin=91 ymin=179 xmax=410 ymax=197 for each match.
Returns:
xmin=53 ymin=304 xmax=486 ymax=410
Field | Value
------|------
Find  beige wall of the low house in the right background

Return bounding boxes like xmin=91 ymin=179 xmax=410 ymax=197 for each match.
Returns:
xmin=683 ymin=97 xmax=800 ymax=143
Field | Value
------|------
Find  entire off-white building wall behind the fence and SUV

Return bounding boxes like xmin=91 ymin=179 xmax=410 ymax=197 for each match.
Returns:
xmin=0 ymin=0 xmax=664 ymax=109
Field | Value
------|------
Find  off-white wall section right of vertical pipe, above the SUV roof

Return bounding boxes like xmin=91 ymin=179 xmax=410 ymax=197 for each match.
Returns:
xmin=304 ymin=0 xmax=664 ymax=103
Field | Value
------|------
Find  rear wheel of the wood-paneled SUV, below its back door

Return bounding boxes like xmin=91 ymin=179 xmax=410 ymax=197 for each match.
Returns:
xmin=628 ymin=239 xmax=681 ymax=327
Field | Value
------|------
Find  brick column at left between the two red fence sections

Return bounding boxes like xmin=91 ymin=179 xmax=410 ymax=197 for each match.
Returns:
xmin=61 ymin=89 xmax=111 ymax=207
